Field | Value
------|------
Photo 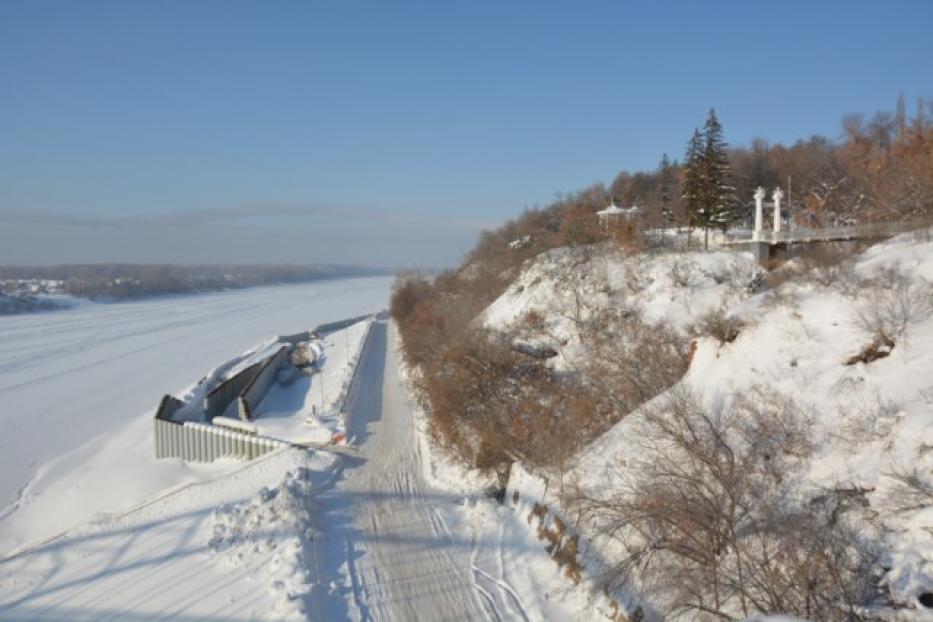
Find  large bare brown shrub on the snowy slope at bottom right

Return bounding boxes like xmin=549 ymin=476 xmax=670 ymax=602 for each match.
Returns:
xmin=577 ymin=388 xmax=881 ymax=620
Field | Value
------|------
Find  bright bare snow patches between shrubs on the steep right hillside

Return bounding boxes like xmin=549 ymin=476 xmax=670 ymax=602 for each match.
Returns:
xmin=483 ymin=234 xmax=933 ymax=619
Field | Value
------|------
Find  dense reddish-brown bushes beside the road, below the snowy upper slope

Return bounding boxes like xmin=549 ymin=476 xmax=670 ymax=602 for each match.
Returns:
xmin=392 ymin=258 xmax=687 ymax=478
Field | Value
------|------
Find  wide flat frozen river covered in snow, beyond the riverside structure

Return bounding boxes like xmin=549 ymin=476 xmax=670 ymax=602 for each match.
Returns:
xmin=0 ymin=277 xmax=392 ymax=520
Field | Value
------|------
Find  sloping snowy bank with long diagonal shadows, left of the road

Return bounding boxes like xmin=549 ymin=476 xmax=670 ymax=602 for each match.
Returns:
xmin=0 ymin=450 xmax=321 ymax=620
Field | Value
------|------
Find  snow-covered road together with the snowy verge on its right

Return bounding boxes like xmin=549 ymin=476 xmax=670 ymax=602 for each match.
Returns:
xmin=312 ymin=323 xmax=589 ymax=620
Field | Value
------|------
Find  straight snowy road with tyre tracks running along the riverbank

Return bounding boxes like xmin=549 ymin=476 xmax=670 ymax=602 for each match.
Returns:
xmin=314 ymin=321 xmax=526 ymax=620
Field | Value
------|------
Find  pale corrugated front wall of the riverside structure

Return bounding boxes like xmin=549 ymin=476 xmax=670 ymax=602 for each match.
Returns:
xmin=153 ymin=419 xmax=288 ymax=462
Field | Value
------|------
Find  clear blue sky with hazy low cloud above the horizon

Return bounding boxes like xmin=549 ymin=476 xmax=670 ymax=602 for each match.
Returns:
xmin=0 ymin=0 xmax=933 ymax=267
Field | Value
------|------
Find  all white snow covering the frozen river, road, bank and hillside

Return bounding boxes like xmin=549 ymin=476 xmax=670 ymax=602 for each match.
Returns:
xmin=0 ymin=235 xmax=933 ymax=620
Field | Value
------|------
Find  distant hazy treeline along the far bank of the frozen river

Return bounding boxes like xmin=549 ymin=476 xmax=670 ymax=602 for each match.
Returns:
xmin=0 ymin=264 xmax=388 ymax=301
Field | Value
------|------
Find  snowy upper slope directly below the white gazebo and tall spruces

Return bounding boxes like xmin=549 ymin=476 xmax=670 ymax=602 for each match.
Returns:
xmin=484 ymin=247 xmax=764 ymax=367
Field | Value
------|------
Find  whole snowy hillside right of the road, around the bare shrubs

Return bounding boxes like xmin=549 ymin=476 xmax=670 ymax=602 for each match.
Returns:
xmin=476 ymin=232 xmax=933 ymax=619
